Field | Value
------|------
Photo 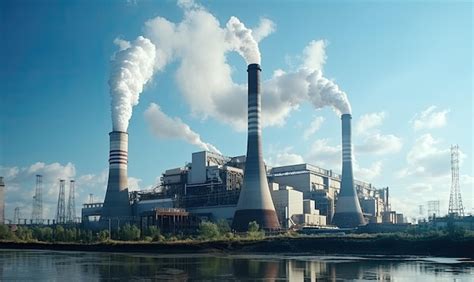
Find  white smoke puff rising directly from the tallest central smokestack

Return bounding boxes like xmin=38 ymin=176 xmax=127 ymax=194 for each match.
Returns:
xmin=226 ymin=17 xmax=262 ymax=64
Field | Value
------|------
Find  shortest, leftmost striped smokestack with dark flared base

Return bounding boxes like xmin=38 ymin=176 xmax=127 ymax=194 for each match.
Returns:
xmin=102 ymin=131 xmax=131 ymax=220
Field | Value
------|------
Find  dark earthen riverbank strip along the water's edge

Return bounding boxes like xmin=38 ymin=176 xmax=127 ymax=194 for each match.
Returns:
xmin=0 ymin=237 xmax=474 ymax=258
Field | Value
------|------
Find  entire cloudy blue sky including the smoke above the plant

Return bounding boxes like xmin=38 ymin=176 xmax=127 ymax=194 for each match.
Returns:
xmin=0 ymin=0 xmax=474 ymax=221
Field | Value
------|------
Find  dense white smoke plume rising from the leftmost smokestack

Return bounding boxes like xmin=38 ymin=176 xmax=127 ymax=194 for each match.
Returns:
xmin=109 ymin=36 xmax=156 ymax=131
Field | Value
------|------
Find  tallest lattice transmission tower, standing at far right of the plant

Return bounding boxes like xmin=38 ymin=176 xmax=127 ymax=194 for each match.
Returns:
xmin=448 ymin=145 xmax=464 ymax=216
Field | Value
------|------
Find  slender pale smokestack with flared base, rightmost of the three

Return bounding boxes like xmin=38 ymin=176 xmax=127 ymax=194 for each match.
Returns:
xmin=332 ymin=114 xmax=365 ymax=228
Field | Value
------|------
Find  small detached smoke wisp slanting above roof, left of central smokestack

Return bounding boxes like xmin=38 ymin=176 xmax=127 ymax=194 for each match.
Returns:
xmin=145 ymin=103 xmax=221 ymax=154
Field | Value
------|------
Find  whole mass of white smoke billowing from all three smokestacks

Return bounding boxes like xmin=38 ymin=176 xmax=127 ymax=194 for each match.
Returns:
xmin=109 ymin=1 xmax=351 ymax=134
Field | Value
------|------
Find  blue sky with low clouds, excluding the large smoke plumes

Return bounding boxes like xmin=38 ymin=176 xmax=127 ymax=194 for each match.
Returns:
xmin=0 ymin=1 xmax=474 ymax=220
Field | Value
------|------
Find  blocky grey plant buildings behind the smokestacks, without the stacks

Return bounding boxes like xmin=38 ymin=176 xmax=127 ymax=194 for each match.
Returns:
xmin=82 ymin=151 xmax=396 ymax=231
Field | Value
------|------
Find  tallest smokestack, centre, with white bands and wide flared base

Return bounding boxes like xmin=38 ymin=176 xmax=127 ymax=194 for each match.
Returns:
xmin=232 ymin=64 xmax=280 ymax=232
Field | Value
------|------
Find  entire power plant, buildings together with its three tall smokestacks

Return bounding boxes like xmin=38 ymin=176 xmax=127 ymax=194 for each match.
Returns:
xmin=82 ymin=64 xmax=403 ymax=232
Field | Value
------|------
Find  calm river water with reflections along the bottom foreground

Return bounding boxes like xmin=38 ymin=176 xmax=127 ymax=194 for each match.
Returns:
xmin=0 ymin=250 xmax=474 ymax=281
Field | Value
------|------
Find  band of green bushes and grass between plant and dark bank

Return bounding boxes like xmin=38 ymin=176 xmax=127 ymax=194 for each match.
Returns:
xmin=0 ymin=223 xmax=474 ymax=244
